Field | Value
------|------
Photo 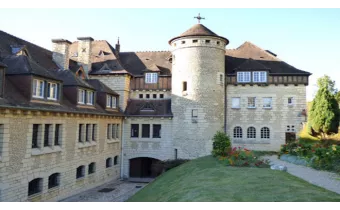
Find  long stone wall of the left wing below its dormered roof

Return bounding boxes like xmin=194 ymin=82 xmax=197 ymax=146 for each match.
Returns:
xmin=0 ymin=110 xmax=122 ymax=201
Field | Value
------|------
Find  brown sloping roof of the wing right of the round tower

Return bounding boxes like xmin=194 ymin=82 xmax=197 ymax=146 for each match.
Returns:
xmin=225 ymin=42 xmax=311 ymax=75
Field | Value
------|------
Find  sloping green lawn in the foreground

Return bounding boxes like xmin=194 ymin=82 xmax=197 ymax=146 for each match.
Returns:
xmin=128 ymin=156 xmax=340 ymax=202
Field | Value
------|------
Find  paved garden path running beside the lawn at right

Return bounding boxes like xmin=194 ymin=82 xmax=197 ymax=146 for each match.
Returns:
xmin=262 ymin=155 xmax=340 ymax=194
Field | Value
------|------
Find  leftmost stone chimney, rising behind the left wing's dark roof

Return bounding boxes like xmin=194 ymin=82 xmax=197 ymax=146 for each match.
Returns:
xmin=52 ymin=39 xmax=72 ymax=70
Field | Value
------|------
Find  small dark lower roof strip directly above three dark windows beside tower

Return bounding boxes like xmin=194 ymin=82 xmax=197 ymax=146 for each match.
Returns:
xmin=125 ymin=99 xmax=173 ymax=117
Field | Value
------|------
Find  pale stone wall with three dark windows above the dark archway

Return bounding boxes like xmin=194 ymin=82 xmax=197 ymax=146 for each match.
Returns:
xmin=122 ymin=117 xmax=175 ymax=178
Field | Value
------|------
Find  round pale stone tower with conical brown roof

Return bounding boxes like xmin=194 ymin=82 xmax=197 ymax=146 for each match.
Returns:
xmin=169 ymin=24 xmax=229 ymax=159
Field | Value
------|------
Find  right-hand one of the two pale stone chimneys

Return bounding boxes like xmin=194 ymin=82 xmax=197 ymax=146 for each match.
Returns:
xmin=77 ymin=37 xmax=94 ymax=78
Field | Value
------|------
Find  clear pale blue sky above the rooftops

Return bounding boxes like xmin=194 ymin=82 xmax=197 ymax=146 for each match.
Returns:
xmin=0 ymin=8 xmax=340 ymax=100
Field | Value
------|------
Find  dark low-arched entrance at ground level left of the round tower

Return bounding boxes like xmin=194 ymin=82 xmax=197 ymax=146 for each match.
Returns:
xmin=130 ymin=157 xmax=162 ymax=178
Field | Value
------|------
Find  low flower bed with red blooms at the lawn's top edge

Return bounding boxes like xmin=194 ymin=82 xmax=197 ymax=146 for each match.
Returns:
xmin=218 ymin=147 xmax=269 ymax=168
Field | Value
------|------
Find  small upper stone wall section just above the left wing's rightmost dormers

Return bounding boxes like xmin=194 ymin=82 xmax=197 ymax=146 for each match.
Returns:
xmin=90 ymin=75 xmax=130 ymax=111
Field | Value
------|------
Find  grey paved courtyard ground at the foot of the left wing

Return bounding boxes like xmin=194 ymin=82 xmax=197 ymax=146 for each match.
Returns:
xmin=59 ymin=180 xmax=147 ymax=202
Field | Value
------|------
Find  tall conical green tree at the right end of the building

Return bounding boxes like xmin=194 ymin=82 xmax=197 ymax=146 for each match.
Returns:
xmin=308 ymin=75 xmax=340 ymax=139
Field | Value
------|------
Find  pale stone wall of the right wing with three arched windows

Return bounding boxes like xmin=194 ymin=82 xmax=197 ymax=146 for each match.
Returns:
xmin=226 ymin=85 xmax=306 ymax=151
